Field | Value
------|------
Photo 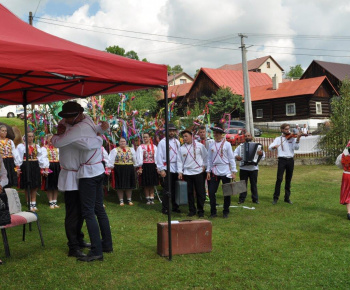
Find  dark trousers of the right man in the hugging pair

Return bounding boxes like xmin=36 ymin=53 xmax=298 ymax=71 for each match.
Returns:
xmin=79 ymin=173 xmax=113 ymax=256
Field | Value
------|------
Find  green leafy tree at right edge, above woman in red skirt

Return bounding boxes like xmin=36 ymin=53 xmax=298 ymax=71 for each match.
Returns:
xmin=319 ymin=80 xmax=350 ymax=161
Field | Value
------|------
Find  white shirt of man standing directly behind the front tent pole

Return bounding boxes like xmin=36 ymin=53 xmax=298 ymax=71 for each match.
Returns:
xmin=156 ymin=138 xmax=180 ymax=173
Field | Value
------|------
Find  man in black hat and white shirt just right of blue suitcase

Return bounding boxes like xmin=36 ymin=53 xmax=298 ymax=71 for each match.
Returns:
xmin=177 ymin=129 xmax=207 ymax=217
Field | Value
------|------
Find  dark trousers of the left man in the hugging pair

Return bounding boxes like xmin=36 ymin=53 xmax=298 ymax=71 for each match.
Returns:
xmin=64 ymin=190 xmax=84 ymax=251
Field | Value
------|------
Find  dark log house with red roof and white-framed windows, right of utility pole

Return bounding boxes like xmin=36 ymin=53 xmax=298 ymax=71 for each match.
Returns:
xmin=250 ymin=76 xmax=338 ymax=126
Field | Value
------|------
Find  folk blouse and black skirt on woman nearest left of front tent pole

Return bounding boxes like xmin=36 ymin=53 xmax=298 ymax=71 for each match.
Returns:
xmin=136 ymin=144 xmax=159 ymax=186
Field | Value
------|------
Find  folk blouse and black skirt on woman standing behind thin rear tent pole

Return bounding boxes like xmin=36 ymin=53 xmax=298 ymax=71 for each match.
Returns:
xmin=16 ymin=144 xmax=48 ymax=189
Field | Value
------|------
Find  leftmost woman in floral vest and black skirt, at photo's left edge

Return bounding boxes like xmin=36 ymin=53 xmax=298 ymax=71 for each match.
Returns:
xmin=0 ymin=125 xmax=18 ymax=187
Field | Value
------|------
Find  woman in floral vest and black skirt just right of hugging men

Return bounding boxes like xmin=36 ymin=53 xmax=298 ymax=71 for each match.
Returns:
xmin=107 ymin=137 xmax=137 ymax=206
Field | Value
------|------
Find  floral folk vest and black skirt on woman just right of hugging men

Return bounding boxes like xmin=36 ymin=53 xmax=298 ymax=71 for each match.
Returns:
xmin=107 ymin=147 xmax=137 ymax=189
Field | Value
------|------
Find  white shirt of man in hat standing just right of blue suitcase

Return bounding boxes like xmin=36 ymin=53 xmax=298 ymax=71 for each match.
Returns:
xmin=177 ymin=141 xmax=207 ymax=175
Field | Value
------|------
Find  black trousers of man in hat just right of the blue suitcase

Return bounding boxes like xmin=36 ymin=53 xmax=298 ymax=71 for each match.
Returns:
xmin=183 ymin=173 xmax=205 ymax=214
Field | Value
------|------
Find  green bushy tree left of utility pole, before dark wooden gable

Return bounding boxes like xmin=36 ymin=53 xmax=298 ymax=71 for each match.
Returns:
xmin=203 ymin=87 xmax=244 ymax=119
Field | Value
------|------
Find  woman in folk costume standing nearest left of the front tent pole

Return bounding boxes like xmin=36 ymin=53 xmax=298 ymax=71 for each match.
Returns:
xmin=136 ymin=133 xmax=159 ymax=204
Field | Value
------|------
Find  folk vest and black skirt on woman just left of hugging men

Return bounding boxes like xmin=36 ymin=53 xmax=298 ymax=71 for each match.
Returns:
xmin=42 ymin=145 xmax=61 ymax=190
